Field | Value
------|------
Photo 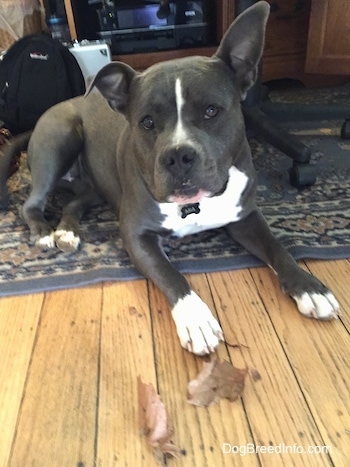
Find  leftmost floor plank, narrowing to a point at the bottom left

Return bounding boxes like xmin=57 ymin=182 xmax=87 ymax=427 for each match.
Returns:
xmin=0 ymin=294 xmax=44 ymax=467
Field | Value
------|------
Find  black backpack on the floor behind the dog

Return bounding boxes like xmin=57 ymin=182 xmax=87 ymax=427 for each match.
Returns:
xmin=0 ymin=33 xmax=85 ymax=134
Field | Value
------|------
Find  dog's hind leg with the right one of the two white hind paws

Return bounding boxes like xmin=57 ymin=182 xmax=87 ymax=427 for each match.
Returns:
xmin=54 ymin=180 xmax=101 ymax=252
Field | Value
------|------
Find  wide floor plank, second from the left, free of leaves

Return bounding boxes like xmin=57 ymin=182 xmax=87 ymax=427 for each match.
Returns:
xmin=9 ymin=286 xmax=102 ymax=467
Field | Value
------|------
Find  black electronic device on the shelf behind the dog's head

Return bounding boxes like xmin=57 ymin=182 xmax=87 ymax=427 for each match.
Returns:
xmin=96 ymin=0 xmax=215 ymax=54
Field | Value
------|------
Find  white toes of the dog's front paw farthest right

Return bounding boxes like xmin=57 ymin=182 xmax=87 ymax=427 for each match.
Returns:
xmin=293 ymin=292 xmax=339 ymax=320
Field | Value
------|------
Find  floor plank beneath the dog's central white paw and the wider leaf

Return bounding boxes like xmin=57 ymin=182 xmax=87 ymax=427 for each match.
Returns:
xmin=150 ymin=274 xmax=258 ymax=467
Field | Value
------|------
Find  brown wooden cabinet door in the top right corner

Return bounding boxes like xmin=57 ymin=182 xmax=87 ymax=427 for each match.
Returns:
xmin=305 ymin=0 xmax=350 ymax=75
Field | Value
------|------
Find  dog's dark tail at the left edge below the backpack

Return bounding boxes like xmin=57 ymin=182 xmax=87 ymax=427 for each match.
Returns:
xmin=0 ymin=131 xmax=32 ymax=209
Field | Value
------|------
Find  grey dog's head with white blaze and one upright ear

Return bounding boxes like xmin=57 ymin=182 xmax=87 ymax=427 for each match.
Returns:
xmin=90 ymin=1 xmax=269 ymax=204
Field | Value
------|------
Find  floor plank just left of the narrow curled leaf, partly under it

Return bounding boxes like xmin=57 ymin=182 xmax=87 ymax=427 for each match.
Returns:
xmin=96 ymin=280 xmax=156 ymax=467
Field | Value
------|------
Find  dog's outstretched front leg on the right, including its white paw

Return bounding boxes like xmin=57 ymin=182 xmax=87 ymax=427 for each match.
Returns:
xmin=227 ymin=211 xmax=339 ymax=319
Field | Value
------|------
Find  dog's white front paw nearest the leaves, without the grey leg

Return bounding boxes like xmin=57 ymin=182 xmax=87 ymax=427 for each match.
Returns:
xmin=171 ymin=291 xmax=224 ymax=355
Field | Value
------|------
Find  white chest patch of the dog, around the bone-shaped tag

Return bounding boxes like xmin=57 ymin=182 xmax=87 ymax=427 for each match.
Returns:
xmin=159 ymin=166 xmax=248 ymax=237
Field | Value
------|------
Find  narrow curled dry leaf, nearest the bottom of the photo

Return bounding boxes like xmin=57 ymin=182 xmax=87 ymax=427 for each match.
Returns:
xmin=137 ymin=376 xmax=180 ymax=457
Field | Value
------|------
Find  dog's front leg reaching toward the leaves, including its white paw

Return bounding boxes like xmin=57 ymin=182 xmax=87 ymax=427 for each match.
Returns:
xmin=122 ymin=229 xmax=223 ymax=355
